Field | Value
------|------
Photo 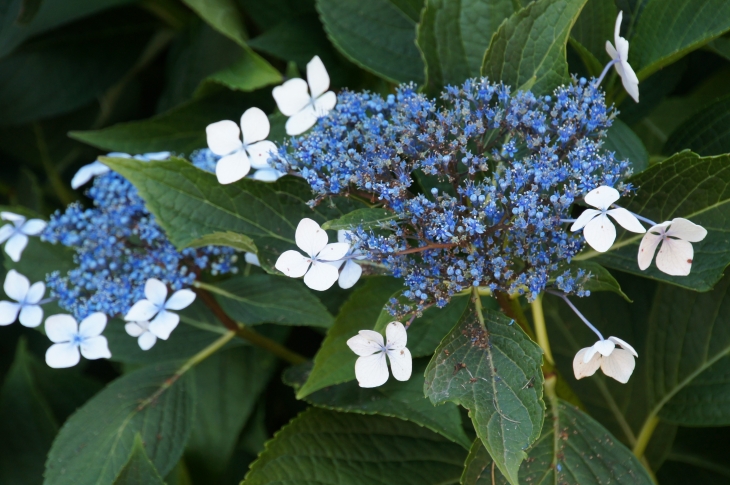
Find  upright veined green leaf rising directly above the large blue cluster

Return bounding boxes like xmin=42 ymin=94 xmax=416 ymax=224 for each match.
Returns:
xmin=482 ymin=0 xmax=587 ymax=94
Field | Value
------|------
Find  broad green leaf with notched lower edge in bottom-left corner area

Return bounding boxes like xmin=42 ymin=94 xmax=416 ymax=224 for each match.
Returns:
xmin=44 ymin=364 xmax=195 ymax=485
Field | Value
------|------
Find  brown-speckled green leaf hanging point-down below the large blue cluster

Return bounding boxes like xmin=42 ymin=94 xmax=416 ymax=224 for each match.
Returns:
xmin=424 ymin=303 xmax=545 ymax=484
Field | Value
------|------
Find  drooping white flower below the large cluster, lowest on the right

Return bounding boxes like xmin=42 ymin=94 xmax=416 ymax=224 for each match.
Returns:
xmin=573 ymin=337 xmax=639 ymax=384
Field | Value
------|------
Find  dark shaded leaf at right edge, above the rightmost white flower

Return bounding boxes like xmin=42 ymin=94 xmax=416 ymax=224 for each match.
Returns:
xmin=662 ymin=96 xmax=730 ymax=156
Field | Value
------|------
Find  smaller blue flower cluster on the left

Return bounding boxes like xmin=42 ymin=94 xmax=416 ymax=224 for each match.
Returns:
xmin=41 ymin=155 xmax=237 ymax=319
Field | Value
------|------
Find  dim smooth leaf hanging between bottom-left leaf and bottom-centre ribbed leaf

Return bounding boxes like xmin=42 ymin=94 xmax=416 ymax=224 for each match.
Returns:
xmin=185 ymin=347 xmax=276 ymax=483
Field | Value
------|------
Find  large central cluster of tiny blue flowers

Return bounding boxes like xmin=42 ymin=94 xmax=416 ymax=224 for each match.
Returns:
xmin=270 ymin=78 xmax=631 ymax=307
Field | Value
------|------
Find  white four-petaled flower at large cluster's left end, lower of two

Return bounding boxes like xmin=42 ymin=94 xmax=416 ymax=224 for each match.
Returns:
xmin=205 ymin=108 xmax=276 ymax=184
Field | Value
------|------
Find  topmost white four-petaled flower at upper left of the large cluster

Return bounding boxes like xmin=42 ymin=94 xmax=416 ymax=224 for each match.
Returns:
xmin=273 ymin=56 xmax=337 ymax=136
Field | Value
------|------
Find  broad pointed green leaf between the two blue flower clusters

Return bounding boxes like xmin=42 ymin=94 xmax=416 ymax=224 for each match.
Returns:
xmin=101 ymin=158 xmax=362 ymax=271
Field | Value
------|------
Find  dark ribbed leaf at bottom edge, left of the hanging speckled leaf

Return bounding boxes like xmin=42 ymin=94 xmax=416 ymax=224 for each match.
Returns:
xmin=242 ymin=408 xmax=466 ymax=485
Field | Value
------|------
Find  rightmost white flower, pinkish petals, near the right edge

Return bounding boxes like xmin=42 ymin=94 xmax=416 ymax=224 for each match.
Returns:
xmin=638 ymin=217 xmax=707 ymax=276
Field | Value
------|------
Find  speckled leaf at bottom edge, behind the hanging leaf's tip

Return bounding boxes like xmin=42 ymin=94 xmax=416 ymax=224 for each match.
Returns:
xmin=461 ymin=399 xmax=654 ymax=485
